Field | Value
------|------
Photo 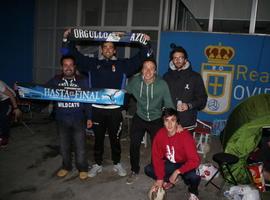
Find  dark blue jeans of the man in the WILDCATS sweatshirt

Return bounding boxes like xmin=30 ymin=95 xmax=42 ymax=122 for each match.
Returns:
xmin=57 ymin=116 xmax=88 ymax=172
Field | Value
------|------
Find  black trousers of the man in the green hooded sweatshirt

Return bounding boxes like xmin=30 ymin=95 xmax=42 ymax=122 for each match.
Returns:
xmin=130 ymin=114 xmax=163 ymax=173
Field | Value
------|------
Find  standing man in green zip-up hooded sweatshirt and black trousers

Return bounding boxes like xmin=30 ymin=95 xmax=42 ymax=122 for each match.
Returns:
xmin=126 ymin=58 xmax=174 ymax=184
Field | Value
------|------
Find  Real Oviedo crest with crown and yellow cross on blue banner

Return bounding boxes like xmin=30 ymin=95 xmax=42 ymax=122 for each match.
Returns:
xmin=201 ymin=44 xmax=235 ymax=114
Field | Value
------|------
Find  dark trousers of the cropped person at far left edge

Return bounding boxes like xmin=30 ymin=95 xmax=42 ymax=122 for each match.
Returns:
xmin=0 ymin=99 xmax=12 ymax=139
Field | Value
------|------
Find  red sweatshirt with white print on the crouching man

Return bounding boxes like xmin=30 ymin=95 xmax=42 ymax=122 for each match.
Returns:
xmin=152 ymin=128 xmax=200 ymax=180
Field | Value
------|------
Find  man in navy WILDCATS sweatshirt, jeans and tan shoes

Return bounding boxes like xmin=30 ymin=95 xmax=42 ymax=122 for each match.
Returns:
xmin=47 ymin=55 xmax=92 ymax=180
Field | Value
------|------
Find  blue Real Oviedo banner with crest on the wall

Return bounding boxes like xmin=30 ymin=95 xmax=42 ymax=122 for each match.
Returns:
xmin=159 ymin=32 xmax=270 ymax=121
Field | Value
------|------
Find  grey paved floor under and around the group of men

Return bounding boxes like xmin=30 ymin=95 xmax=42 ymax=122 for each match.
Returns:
xmin=0 ymin=113 xmax=232 ymax=200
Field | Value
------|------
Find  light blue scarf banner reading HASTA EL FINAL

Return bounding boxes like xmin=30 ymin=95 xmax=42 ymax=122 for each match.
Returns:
xmin=17 ymin=83 xmax=124 ymax=105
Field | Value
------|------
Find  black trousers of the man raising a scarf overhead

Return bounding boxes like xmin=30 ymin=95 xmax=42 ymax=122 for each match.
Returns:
xmin=92 ymin=107 xmax=123 ymax=165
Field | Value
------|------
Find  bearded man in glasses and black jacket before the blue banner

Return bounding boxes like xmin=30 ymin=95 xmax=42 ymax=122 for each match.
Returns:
xmin=164 ymin=47 xmax=207 ymax=130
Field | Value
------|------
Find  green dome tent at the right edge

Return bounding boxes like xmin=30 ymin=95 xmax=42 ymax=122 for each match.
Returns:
xmin=221 ymin=94 xmax=270 ymax=184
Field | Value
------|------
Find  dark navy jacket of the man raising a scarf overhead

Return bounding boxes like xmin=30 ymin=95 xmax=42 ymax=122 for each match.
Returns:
xmin=63 ymin=41 xmax=151 ymax=89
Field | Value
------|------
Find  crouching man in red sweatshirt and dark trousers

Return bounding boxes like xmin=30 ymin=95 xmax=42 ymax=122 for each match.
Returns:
xmin=144 ymin=108 xmax=200 ymax=200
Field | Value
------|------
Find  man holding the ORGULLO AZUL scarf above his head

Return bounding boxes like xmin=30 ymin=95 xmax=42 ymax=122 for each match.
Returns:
xmin=63 ymin=29 xmax=154 ymax=177
